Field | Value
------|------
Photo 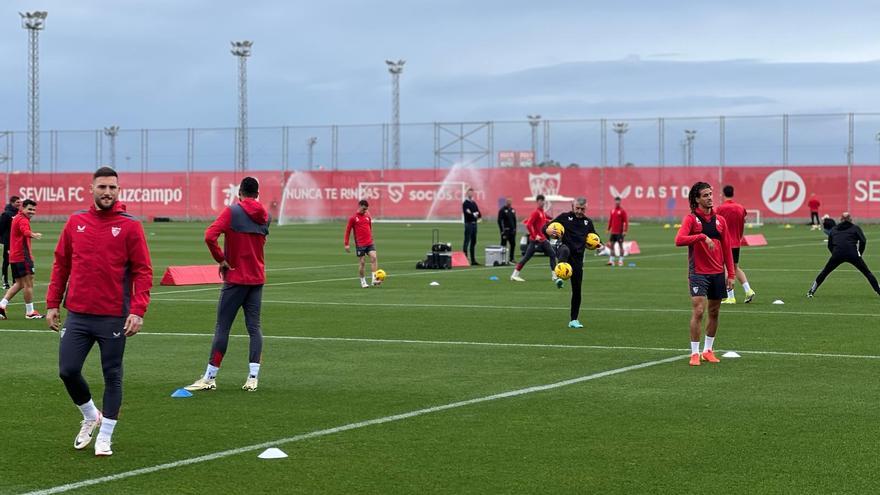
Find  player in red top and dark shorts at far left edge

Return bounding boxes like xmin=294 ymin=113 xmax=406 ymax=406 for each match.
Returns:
xmin=0 ymin=199 xmax=43 ymax=320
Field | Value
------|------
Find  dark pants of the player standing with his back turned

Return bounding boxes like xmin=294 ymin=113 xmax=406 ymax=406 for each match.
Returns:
xmin=209 ymin=283 xmax=263 ymax=368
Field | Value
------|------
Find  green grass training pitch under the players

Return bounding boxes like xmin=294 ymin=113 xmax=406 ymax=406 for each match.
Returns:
xmin=0 ymin=223 xmax=880 ymax=494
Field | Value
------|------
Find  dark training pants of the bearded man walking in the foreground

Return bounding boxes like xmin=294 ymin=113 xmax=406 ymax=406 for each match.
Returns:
xmin=58 ymin=311 xmax=126 ymax=419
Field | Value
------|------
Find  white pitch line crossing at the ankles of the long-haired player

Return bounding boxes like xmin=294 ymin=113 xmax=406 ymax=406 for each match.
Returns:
xmin=0 ymin=329 xmax=880 ymax=359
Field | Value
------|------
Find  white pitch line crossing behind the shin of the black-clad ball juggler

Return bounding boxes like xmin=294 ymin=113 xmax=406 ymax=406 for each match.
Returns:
xmin=152 ymin=297 xmax=880 ymax=318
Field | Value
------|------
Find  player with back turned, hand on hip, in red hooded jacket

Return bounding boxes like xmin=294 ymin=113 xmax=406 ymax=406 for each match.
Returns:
xmin=184 ymin=177 xmax=269 ymax=392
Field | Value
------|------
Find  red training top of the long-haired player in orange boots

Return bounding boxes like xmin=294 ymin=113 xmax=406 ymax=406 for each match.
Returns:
xmin=675 ymin=210 xmax=736 ymax=280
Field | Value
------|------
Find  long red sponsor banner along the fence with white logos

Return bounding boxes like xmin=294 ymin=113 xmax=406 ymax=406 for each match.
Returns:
xmin=0 ymin=166 xmax=880 ymax=222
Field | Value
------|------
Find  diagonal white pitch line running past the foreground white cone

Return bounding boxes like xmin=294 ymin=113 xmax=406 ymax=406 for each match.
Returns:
xmin=25 ymin=354 xmax=688 ymax=495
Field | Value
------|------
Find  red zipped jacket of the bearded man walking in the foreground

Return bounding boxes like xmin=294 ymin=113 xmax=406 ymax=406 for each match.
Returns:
xmin=46 ymin=202 xmax=153 ymax=317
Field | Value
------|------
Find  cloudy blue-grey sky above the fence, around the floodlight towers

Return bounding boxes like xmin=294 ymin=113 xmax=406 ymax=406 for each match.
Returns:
xmin=0 ymin=0 xmax=880 ymax=169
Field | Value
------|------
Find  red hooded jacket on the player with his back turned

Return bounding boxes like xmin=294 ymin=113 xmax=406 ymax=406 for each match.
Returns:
xmin=205 ymin=198 xmax=269 ymax=285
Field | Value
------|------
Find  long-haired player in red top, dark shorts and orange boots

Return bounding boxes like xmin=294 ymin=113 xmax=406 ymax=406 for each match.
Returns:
xmin=675 ymin=182 xmax=736 ymax=366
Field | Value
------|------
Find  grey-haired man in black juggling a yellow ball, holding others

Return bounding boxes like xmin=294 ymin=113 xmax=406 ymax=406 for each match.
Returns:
xmin=545 ymin=198 xmax=596 ymax=328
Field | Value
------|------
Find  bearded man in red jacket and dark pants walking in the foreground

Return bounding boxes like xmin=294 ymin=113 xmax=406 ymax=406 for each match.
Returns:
xmin=46 ymin=167 xmax=153 ymax=456
